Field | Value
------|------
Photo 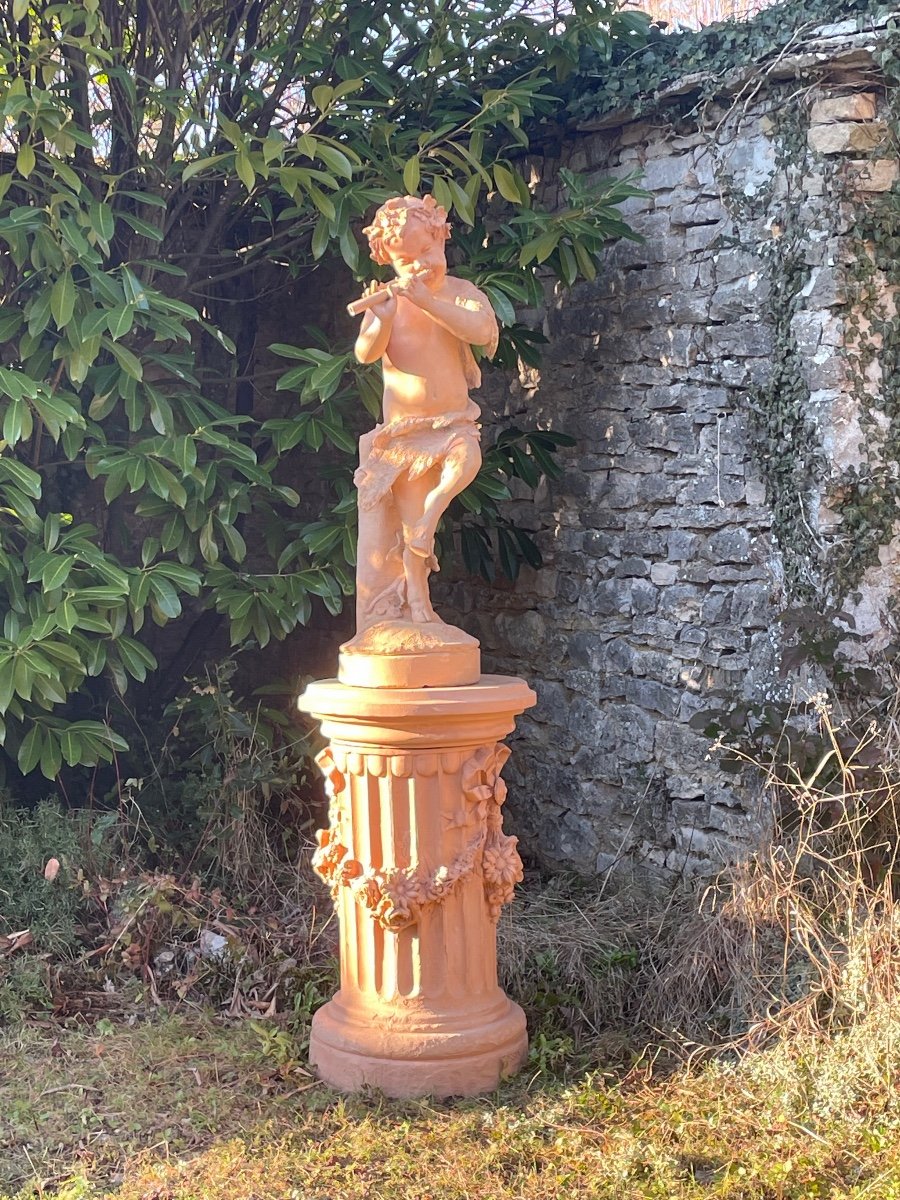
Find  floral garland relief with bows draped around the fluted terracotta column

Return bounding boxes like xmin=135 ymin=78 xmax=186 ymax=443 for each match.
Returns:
xmin=312 ymin=742 xmax=522 ymax=932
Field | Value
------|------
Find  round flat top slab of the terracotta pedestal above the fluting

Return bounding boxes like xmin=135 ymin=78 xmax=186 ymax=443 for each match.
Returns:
xmin=298 ymin=676 xmax=538 ymax=719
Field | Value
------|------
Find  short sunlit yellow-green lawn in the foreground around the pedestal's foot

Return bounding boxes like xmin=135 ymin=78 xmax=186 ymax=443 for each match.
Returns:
xmin=0 ymin=1012 xmax=900 ymax=1200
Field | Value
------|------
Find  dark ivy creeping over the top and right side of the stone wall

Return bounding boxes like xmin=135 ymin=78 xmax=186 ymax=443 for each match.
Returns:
xmin=568 ymin=0 xmax=900 ymax=612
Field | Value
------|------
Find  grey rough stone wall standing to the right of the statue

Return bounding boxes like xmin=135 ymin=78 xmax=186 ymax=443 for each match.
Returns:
xmin=442 ymin=14 xmax=896 ymax=882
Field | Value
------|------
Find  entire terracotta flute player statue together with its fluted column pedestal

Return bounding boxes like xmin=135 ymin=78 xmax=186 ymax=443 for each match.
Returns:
xmin=299 ymin=189 xmax=536 ymax=1097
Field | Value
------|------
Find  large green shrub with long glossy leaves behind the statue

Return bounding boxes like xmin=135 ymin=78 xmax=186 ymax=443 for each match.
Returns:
xmin=0 ymin=0 xmax=646 ymax=779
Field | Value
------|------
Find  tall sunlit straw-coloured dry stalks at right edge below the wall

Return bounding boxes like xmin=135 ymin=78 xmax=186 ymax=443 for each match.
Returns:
xmin=641 ymin=697 xmax=900 ymax=1045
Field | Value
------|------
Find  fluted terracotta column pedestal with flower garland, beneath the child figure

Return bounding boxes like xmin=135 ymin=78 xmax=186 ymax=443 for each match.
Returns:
xmin=300 ymin=676 xmax=535 ymax=1097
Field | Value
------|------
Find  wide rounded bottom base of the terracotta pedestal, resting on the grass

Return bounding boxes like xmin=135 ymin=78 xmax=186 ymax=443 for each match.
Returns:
xmin=310 ymin=992 xmax=528 ymax=1098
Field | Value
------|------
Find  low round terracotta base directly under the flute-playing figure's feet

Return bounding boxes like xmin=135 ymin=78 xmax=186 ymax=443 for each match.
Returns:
xmin=337 ymin=620 xmax=481 ymax=688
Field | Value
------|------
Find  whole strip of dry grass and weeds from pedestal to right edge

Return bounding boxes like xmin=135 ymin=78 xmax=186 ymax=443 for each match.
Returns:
xmin=499 ymin=697 xmax=900 ymax=1051
